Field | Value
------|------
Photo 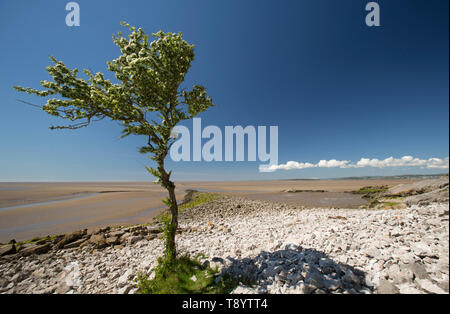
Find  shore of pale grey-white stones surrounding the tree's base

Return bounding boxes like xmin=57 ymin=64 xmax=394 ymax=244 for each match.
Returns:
xmin=0 ymin=191 xmax=449 ymax=293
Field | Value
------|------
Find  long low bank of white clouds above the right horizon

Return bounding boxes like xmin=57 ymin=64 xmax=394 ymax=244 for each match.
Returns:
xmin=259 ymin=156 xmax=449 ymax=172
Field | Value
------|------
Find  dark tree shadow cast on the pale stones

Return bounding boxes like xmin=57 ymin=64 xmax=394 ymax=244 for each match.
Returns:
xmin=212 ymin=244 xmax=373 ymax=294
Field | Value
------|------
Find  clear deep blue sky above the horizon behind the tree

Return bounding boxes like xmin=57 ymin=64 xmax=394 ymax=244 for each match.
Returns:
xmin=0 ymin=0 xmax=449 ymax=181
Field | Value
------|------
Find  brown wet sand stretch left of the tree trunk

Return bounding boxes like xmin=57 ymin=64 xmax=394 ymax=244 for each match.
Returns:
xmin=0 ymin=183 xmax=184 ymax=242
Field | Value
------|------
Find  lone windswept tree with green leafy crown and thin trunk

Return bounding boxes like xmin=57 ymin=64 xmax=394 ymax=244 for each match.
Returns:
xmin=14 ymin=22 xmax=213 ymax=262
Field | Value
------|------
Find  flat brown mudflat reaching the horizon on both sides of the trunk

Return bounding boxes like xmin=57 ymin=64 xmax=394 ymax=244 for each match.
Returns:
xmin=0 ymin=180 xmax=411 ymax=242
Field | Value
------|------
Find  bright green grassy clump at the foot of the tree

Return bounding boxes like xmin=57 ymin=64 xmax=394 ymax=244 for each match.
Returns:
xmin=138 ymin=256 xmax=255 ymax=294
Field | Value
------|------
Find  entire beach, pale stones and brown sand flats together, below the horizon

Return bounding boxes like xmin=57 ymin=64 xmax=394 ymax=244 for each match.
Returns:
xmin=0 ymin=176 xmax=449 ymax=294
